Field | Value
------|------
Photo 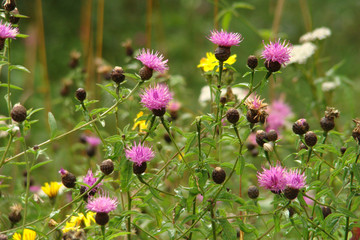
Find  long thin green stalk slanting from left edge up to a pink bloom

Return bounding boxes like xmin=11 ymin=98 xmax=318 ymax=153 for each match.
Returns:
xmin=5 ymin=81 xmax=143 ymax=163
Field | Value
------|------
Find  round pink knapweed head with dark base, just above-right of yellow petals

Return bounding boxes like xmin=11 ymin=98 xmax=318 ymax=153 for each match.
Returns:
xmin=140 ymin=84 xmax=172 ymax=116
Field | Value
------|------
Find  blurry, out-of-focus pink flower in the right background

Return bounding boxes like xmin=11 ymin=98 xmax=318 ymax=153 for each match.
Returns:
xmin=266 ymin=100 xmax=292 ymax=132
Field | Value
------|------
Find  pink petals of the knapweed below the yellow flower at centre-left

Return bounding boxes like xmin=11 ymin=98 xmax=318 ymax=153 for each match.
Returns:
xmin=125 ymin=142 xmax=155 ymax=166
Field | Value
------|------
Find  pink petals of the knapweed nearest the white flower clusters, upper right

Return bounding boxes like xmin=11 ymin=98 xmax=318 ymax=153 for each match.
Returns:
xmin=261 ymin=39 xmax=292 ymax=66
